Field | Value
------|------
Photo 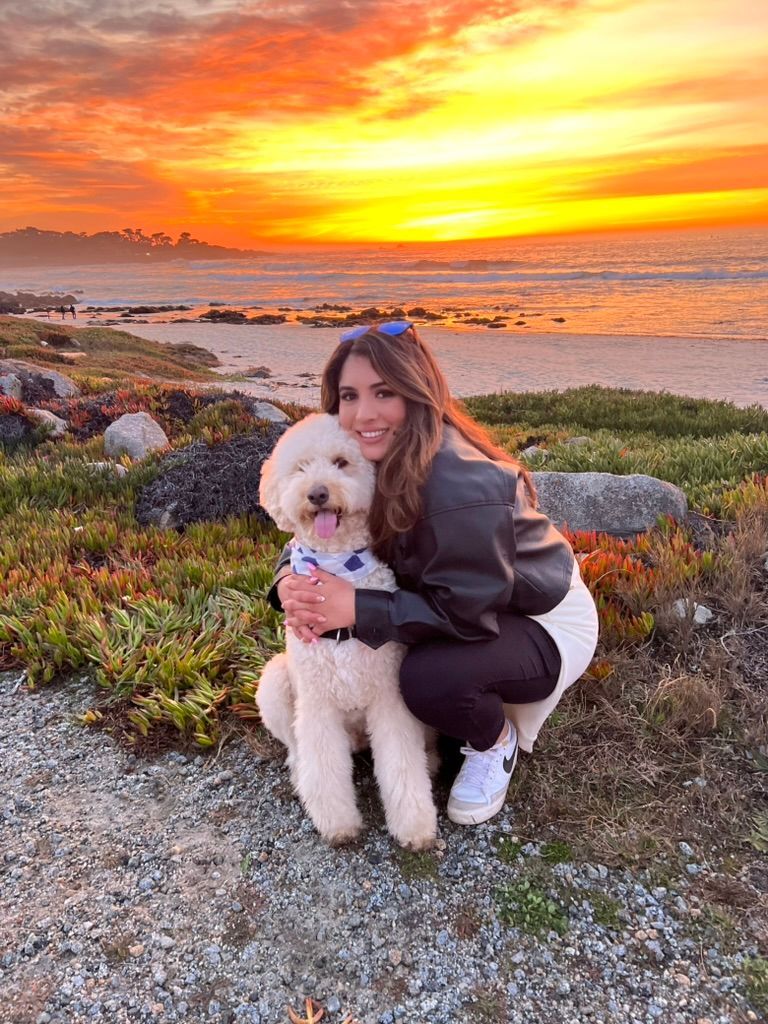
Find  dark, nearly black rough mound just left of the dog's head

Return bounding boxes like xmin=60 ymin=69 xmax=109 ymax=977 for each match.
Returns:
xmin=136 ymin=423 xmax=286 ymax=528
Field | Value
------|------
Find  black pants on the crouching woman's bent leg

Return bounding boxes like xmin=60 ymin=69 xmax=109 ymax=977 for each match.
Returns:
xmin=400 ymin=612 xmax=560 ymax=751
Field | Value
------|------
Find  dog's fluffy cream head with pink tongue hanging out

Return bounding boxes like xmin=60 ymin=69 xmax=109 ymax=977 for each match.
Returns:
xmin=259 ymin=413 xmax=376 ymax=552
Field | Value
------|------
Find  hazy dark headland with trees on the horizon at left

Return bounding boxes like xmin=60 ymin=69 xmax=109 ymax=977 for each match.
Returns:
xmin=0 ymin=227 xmax=266 ymax=267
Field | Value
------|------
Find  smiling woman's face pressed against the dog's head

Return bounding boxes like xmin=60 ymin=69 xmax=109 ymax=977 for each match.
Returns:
xmin=339 ymin=355 xmax=407 ymax=462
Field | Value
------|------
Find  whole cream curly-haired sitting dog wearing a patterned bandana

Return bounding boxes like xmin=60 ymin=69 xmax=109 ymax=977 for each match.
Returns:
xmin=256 ymin=414 xmax=437 ymax=850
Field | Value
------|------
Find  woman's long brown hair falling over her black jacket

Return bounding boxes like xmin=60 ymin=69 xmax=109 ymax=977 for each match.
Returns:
xmin=321 ymin=326 xmax=536 ymax=556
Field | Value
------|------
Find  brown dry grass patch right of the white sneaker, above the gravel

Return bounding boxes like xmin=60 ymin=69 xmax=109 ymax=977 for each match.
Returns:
xmin=511 ymin=569 xmax=768 ymax=863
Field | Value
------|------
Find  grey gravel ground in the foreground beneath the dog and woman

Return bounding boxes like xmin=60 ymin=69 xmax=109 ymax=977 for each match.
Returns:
xmin=0 ymin=674 xmax=761 ymax=1024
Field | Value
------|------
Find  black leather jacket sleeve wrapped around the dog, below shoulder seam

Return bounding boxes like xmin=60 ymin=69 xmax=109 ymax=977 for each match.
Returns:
xmin=355 ymin=502 xmax=515 ymax=648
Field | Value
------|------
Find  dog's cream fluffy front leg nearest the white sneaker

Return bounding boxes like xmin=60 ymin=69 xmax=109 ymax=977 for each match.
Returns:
xmin=368 ymin=690 xmax=437 ymax=850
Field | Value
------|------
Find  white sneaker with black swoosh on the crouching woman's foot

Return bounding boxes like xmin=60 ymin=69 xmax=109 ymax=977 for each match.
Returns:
xmin=447 ymin=722 xmax=517 ymax=825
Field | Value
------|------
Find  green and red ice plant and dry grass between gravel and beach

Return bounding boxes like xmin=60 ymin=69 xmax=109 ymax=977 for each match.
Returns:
xmin=0 ymin=322 xmax=768 ymax=888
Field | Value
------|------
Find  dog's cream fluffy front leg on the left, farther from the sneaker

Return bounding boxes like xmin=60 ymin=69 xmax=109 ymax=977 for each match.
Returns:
xmin=296 ymin=696 xmax=362 ymax=846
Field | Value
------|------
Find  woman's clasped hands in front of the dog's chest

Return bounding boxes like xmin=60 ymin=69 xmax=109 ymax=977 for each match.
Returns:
xmin=278 ymin=568 xmax=354 ymax=643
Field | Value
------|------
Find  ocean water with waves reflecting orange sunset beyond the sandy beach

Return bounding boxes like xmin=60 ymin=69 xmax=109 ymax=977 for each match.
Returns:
xmin=0 ymin=229 xmax=768 ymax=341
